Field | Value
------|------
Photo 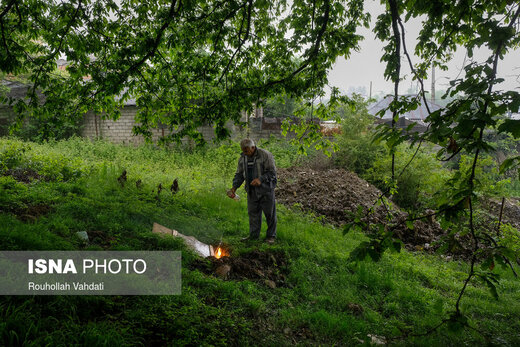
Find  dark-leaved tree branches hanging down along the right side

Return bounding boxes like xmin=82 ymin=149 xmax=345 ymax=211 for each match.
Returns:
xmin=346 ymin=0 xmax=520 ymax=338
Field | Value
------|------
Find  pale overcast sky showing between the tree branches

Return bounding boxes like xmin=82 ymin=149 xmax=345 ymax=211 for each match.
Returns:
xmin=329 ymin=0 xmax=520 ymax=98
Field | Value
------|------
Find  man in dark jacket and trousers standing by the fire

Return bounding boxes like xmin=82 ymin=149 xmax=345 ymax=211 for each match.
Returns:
xmin=228 ymin=139 xmax=277 ymax=244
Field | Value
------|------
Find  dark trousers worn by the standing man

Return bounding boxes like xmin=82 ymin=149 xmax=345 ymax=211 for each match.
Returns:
xmin=247 ymin=186 xmax=277 ymax=239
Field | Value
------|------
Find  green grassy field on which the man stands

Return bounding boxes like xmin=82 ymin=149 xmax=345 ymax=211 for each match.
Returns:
xmin=0 ymin=138 xmax=520 ymax=346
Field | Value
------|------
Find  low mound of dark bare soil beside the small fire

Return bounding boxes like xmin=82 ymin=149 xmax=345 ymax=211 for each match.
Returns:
xmin=191 ymin=250 xmax=288 ymax=288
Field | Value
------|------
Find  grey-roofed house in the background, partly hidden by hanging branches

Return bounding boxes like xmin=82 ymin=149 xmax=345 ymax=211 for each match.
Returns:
xmin=368 ymin=95 xmax=441 ymax=132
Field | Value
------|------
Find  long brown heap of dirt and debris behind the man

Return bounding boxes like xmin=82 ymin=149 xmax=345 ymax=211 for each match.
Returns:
xmin=276 ymin=167 xmax=444 ymax=249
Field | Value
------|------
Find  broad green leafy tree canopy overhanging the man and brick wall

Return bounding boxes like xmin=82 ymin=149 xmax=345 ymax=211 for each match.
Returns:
xmin=0 ymin=0 xmax=369 ymax=142
